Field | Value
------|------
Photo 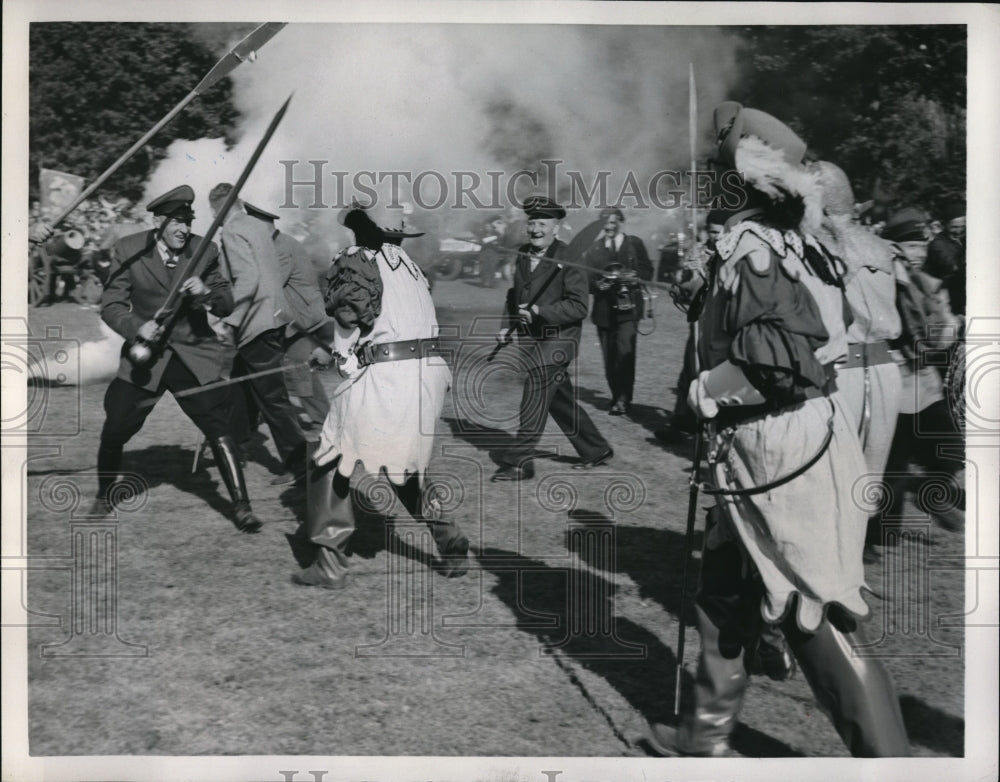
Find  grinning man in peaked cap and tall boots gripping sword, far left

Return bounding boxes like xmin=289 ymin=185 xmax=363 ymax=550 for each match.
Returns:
xmin=95 ymin=185 xmax=262 ymax=532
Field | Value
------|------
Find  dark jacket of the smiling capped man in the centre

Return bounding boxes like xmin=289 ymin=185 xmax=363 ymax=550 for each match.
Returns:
xmin=504 ymin=239 xmax=587 ymax=366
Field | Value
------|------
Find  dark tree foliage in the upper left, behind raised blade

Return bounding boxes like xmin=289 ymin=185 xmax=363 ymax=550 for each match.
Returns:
xmin=29 ymin=22 xmax=238 ymax=200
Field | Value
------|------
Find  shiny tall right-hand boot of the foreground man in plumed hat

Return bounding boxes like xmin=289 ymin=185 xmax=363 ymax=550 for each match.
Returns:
xmin=783 ymin=612 xmax=910 ymax=758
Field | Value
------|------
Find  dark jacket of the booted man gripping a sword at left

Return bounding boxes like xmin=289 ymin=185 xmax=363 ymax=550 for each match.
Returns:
xmin=101 ymin=231 xmax=233 ymax=390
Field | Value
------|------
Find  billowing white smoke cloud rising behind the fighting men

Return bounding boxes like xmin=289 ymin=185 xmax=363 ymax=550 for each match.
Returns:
xmin=145 ymin=24 xmax=735 ymax=254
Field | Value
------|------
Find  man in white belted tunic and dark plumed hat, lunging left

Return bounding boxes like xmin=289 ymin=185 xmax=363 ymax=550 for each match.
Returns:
xmin=292 ymin=205 xmax=469 ymax=589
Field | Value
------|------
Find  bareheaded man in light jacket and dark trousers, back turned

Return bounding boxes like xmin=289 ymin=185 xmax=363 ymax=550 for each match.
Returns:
xmin=208 ymin=182 xmax=306 ymax=486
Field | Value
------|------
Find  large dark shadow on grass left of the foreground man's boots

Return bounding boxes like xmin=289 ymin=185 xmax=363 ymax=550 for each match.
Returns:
xmin=479 ymin=536 xmax=801 ymax=757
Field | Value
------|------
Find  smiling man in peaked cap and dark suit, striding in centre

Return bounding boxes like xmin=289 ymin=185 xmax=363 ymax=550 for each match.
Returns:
xmin=491 ymin=196 xmax=614 ymax=481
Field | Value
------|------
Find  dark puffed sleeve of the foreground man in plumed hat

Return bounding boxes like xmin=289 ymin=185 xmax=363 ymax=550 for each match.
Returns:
xmin=726 ymin=259 xmax=828 ymax=405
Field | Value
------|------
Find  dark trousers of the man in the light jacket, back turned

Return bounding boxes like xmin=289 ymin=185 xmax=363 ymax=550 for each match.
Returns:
xmin=233 ymin=329 xmax=306 ymax=467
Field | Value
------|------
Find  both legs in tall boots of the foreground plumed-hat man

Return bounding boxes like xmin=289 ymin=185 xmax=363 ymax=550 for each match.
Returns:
xmin=678 ymin=543 xmax=910 ymax=757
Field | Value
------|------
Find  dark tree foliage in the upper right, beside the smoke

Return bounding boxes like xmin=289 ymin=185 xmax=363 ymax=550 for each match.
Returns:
xmin=733 ymin=25 xmax=967 ymax=214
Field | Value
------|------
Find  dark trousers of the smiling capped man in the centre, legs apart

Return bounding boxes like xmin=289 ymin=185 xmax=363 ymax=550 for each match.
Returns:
xmin=501 ymin=364 xmax=610 ymax=466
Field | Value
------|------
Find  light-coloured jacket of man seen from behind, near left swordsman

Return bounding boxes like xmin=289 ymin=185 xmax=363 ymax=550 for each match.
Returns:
xmin=222 ymin=212 xmax=292 ymax=347
